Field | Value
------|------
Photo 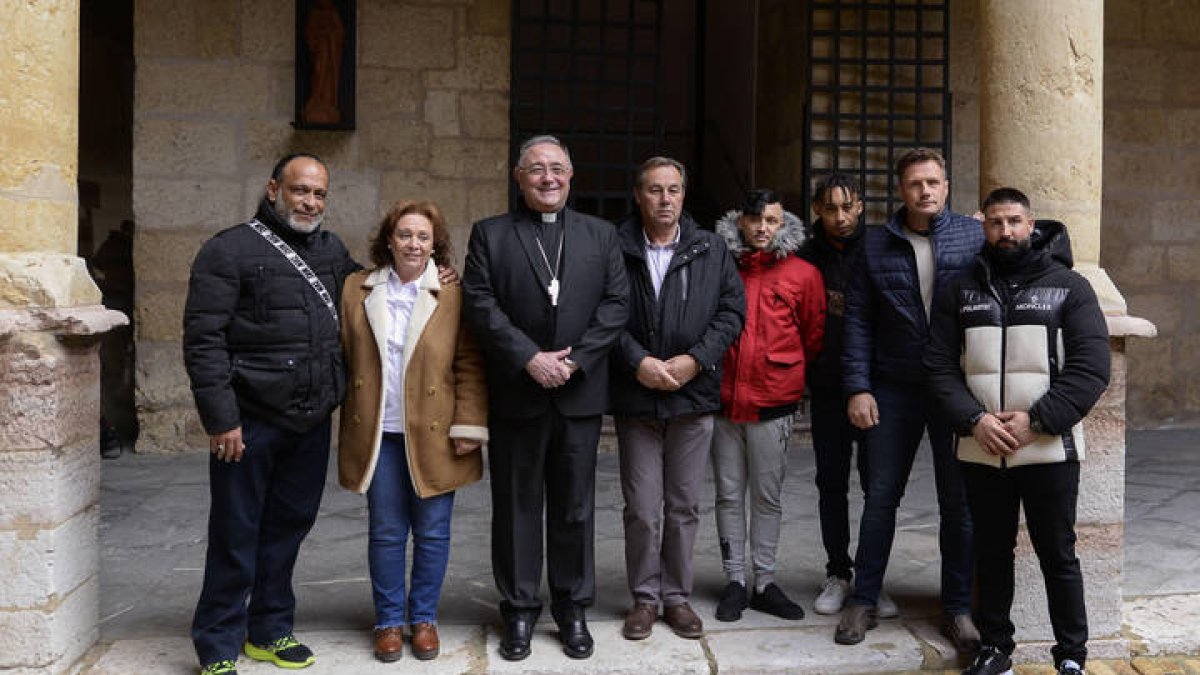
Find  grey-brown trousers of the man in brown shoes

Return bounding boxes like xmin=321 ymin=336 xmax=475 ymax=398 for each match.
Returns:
xmin=616 ymin=414 xmax=713 ymax=607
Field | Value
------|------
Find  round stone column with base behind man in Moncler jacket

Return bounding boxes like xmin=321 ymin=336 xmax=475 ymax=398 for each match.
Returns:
xmin=977 ymin=0 xmax=1154 ymax=661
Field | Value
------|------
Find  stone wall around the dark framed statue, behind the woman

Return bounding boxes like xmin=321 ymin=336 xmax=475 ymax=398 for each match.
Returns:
xmin=133 ymin=0 xmax=509 ymax=452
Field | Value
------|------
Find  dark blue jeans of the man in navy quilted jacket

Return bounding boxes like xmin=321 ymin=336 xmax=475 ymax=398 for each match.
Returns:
xmin=850 ymin=382 xmax=971 ymax=615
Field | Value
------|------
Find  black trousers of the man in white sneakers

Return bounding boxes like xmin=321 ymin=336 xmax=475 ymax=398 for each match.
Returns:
xmin=809 ymin=387 xmax=866 ymax=581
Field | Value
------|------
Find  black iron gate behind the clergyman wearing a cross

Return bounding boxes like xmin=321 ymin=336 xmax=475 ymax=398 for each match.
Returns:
xmin=510 ymin=0 xmax=662 ymax=220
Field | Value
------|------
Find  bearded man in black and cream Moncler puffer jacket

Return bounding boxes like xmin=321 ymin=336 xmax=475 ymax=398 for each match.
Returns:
xmin=924 ymin=187 xmax=1110 ymax=675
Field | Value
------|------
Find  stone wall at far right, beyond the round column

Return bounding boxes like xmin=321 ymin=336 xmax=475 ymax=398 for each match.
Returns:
xmin=1100 ymin=0 xmax=1200 ymax=428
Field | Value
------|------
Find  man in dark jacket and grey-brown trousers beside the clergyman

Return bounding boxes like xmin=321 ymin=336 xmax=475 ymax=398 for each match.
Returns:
xmin=611 ymin=157 xmax=745 ymax=640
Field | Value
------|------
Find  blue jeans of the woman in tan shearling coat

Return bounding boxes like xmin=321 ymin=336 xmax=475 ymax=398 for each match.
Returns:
xmin=367 ymin=434 xmax=454 ymax=628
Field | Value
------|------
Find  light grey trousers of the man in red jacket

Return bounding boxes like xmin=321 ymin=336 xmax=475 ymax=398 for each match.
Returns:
xmin=713 ymin=414 xmax=792 ymax=589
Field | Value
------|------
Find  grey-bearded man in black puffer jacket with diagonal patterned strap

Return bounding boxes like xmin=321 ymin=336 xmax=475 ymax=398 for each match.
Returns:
xmin=184 ymin=154 xmax=358 ymax=675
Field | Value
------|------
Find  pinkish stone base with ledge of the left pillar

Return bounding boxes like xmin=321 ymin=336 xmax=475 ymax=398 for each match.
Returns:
xmin=0 ymin=302 xmax=125 ymax=673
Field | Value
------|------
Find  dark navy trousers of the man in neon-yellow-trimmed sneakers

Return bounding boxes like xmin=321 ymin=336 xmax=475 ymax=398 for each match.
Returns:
xmin=192 ymin=418 xmax=330 ymax=664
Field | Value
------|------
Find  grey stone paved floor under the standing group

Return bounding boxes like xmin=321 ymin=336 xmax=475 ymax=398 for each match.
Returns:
xmin=85 ymin=430 xmax=1200 ymax=675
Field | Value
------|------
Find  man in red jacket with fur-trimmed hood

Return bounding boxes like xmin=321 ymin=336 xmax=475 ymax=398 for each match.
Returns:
xmin=713 ymin=190 xmax=826 ymax=621
